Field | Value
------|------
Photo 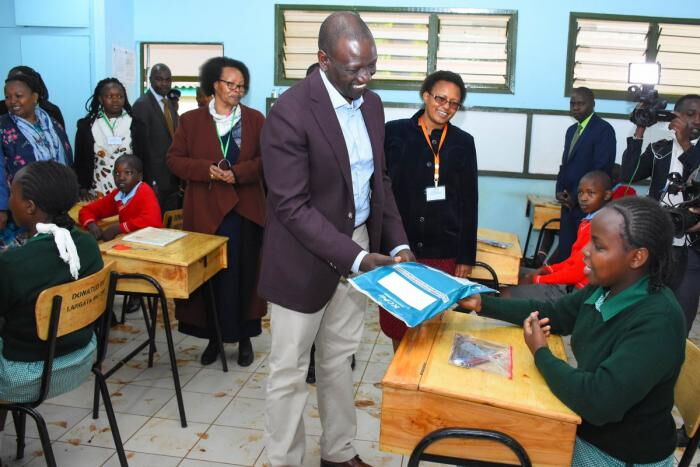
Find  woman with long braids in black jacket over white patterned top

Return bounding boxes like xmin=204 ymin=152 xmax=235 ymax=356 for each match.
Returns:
xmin=73 ymin=78 xmax=148 ymax=198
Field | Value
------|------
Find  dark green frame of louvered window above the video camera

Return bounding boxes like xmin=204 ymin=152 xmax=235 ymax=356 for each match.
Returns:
xmin=565 ymin=12 xmax=700 ymax=101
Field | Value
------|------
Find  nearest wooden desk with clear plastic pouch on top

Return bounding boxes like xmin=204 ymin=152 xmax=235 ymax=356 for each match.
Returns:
xmin=379 ymin=311 xmax=581 ymax=466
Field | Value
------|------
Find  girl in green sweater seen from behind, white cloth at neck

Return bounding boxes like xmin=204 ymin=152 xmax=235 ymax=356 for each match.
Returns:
xmin=0 ymin=161 xmax=102 ymax=454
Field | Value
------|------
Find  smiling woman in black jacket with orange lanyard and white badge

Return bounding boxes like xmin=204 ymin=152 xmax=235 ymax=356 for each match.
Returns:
xmin=380 ymin=71 xmax=478 ymax=348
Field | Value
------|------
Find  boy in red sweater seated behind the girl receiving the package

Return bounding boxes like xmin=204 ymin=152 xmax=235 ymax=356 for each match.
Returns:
xmin=502 ymin=170 xmax=612 ymax=299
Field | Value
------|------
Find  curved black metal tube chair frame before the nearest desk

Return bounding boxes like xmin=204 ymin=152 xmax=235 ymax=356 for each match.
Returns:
xmin=408 ymin=428 xmax=532 ymax=467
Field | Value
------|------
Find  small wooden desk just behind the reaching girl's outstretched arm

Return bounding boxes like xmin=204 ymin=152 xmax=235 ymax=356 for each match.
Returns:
xmin=470 ymin=228 xmax=523 ymax=285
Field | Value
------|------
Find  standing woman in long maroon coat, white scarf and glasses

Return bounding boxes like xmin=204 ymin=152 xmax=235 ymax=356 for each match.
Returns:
xmin=167 ymin=57 xmax=266 ymax=366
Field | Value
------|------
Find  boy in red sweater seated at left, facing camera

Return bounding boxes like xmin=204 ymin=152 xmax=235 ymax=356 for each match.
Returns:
xmin=78 ymin=154 xmax=163 ymax=240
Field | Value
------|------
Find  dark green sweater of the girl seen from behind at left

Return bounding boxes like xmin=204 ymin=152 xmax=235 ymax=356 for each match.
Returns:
xmin=0 ymin=227 xmax=102 ymax=362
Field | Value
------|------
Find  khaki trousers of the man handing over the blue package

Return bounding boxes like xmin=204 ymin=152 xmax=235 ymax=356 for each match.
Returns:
xmin=265 ymin=225 xmax=369 ymax=466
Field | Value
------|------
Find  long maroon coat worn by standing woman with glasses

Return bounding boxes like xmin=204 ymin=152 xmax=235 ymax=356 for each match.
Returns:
xmin=166 ymin=104 xmax=267 ymax=327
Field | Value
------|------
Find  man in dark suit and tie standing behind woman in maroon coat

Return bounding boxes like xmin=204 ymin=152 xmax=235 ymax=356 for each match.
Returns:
xmin=132 ymin=63 xmax=181 ymax=212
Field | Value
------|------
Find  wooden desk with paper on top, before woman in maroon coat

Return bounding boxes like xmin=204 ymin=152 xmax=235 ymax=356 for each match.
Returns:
xmin=100 ymin=232 xmax=228 ymax=298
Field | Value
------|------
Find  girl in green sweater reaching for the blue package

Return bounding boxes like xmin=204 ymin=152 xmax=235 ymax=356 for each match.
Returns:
xmin=460 ymin=197 xmax=686 ymax=467
